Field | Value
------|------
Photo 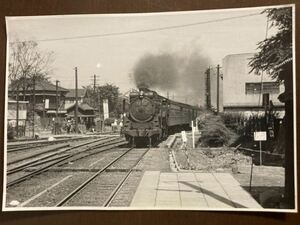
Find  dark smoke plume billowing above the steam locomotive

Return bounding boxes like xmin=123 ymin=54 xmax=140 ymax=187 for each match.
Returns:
xmin=133 ymin=48 xmax=210 ymax=105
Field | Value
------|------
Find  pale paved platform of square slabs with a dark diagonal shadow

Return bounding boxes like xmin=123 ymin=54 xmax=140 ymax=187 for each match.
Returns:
xmin=130 ymin=171 xmax=262 ymax=209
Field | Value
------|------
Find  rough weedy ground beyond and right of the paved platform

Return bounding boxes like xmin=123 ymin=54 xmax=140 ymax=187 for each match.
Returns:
xmin=173 ymin=135 xmax=284 ymax=208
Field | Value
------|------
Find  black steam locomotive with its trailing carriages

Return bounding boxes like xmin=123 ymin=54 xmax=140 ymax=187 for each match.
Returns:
xmin=122 ymin=88 xmax=200 ymax=146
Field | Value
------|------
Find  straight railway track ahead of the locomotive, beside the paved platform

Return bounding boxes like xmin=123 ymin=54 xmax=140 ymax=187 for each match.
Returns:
xmin=56 ymin=148 xmax=150 ymax=207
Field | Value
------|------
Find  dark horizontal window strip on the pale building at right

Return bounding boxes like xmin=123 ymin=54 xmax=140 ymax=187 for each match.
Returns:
xmin=245 ymin=82 xmax=280 ymax=95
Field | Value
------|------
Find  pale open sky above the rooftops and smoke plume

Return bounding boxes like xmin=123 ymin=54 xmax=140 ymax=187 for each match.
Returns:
xmin=7 ymin=5 xmax=278 ymax=92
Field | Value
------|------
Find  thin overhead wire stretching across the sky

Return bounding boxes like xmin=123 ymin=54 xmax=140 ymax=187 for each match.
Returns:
xmin=10 ymin=13 xmax=261 ymax=43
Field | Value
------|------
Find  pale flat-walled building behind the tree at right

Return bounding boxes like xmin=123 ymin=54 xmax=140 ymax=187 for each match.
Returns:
xmin=222 ymin=53 xmax=284 ymax=117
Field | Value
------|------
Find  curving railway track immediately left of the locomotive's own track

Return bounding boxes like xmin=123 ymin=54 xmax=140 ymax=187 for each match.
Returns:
xmin=6 ymin=137 xmax=127 ymax=188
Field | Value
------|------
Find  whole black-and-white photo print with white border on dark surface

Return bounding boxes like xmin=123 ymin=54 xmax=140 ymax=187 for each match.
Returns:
xmin=2 ymin=4 xmax=298 ymax=213
